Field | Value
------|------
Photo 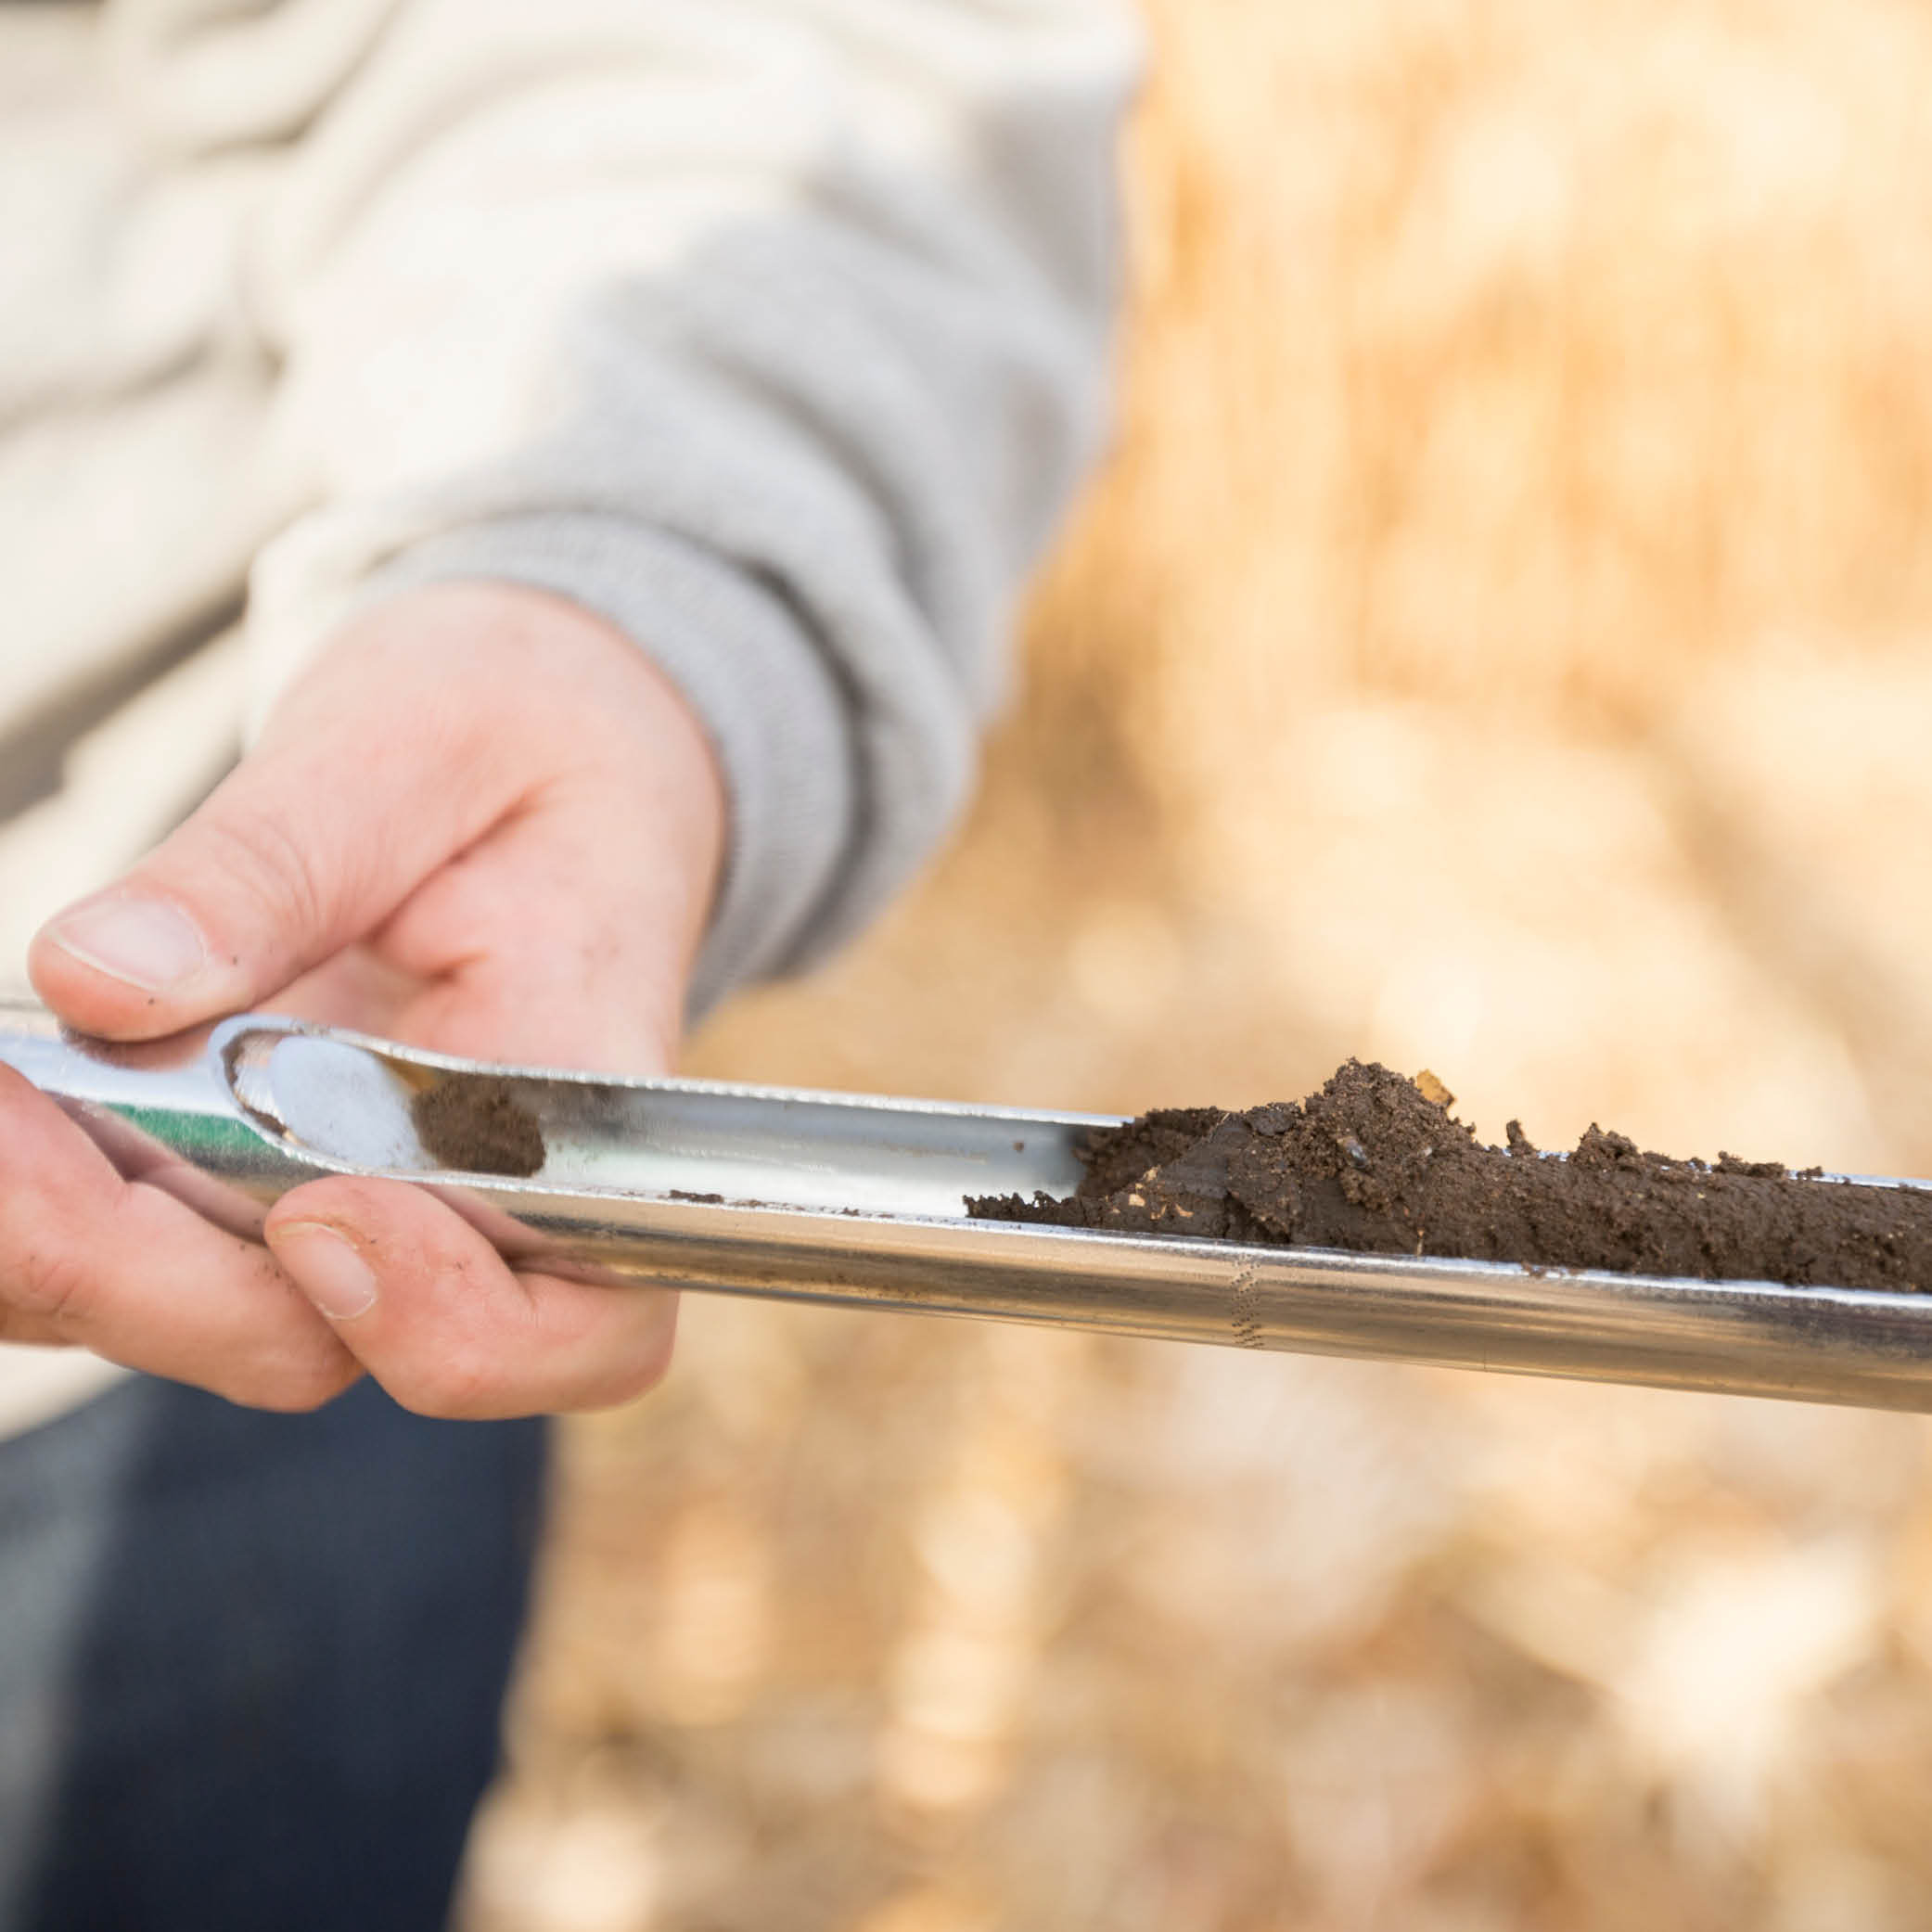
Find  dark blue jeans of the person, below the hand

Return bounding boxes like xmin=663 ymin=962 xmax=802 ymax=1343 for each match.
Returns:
xmin=0 ymin=1379 xmax=544 ymax=1932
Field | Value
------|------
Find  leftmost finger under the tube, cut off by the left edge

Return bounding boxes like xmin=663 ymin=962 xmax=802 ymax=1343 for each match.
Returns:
xmin=0 ymin=1068 xmax=359 ymax=1409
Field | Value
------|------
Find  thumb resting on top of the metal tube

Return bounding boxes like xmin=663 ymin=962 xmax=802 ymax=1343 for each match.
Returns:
xmin=27 ymin=664 xmax=510 ymax=1040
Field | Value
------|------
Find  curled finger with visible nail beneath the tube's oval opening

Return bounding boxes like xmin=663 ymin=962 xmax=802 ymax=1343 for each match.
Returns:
xmin=269 ymin=1177 xmax=678 ymax=1418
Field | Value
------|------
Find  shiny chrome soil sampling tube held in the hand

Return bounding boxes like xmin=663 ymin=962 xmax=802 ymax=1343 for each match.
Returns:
xmin=0 ymin=1003 xmax=1932 ymax=1413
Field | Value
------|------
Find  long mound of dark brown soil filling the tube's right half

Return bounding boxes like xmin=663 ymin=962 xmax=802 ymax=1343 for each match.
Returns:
xmin=966 ymin=1061 xmax=1932 ymax=1290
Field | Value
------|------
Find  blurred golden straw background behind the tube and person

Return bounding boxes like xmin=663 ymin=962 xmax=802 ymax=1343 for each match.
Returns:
xmin=462 ymin=0 xmax=1932 ymax=1932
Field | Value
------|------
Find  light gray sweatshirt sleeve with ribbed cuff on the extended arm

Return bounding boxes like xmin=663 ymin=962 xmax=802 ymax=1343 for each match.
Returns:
xmin=248 ymin=0 xmax=1138 ymax=1006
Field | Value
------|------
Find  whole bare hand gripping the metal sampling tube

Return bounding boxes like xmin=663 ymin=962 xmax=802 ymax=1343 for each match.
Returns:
xmin=0 ymin=583 xmax=724 ymax=1416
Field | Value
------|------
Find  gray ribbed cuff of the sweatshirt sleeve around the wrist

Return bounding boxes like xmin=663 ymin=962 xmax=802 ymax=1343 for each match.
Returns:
xmin=357 ymin=512 xmax=858 ymax=1018
